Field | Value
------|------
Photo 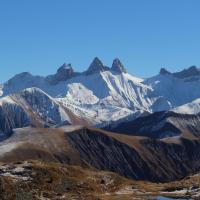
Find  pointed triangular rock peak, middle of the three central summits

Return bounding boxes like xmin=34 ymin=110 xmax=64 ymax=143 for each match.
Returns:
xmin=86 ymin=57 xmax=109 ymax=74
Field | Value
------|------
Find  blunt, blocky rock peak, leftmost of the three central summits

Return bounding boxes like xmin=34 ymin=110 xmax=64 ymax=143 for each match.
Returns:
xmin=56 ymin=63 xmax=74 ymax=81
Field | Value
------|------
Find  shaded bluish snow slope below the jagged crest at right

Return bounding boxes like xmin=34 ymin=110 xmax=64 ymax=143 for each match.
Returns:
xmin=143 ymin=74 xmax=200 ymax=108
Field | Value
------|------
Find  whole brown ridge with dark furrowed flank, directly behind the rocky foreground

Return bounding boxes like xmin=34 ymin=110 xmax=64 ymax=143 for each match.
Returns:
xmin=0 ymin=126 xmax=200 ymax=182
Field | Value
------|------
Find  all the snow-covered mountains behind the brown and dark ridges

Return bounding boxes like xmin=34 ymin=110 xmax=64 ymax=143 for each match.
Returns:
xmin=0 ymin=58 xmax=200 ymax=134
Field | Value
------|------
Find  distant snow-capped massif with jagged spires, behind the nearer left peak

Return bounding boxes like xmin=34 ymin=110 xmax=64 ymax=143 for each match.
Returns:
xmin=0 ymin=58 xmax=200 ymax=128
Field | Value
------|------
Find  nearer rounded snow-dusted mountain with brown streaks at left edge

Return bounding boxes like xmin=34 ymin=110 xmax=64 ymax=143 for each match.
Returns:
xmin=0 ymin=88 xmax=84 ymax=140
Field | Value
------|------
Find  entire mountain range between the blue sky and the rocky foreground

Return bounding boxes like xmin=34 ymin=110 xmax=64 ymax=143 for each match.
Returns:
xmin=0 ymin=57 xmax=200 ymax=198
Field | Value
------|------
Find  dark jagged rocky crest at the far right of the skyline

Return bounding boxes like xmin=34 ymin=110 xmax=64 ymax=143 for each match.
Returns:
xmin=173 ymin=66 xmax=200 ymax=78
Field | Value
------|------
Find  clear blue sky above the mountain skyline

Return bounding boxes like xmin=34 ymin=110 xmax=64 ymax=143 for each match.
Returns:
xmin=0 ymin=0 xmax=200 ymax=82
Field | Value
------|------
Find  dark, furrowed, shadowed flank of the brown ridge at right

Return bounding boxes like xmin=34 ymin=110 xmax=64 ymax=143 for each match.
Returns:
xmin=67 ymin=128 xmax=200 ymax=182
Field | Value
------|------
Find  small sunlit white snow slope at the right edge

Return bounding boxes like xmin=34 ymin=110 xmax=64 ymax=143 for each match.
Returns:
xmin=172 ymin=98 xmax=200 ymax=114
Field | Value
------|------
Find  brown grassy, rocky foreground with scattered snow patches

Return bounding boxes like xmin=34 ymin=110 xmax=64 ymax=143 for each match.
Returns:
xmin=0 ymin=161 xmax=200 ymax=200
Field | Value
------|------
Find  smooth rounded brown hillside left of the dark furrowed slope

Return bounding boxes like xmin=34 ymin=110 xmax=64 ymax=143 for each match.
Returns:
xmin=0 ymin=128 xmax=83 ymax=165
